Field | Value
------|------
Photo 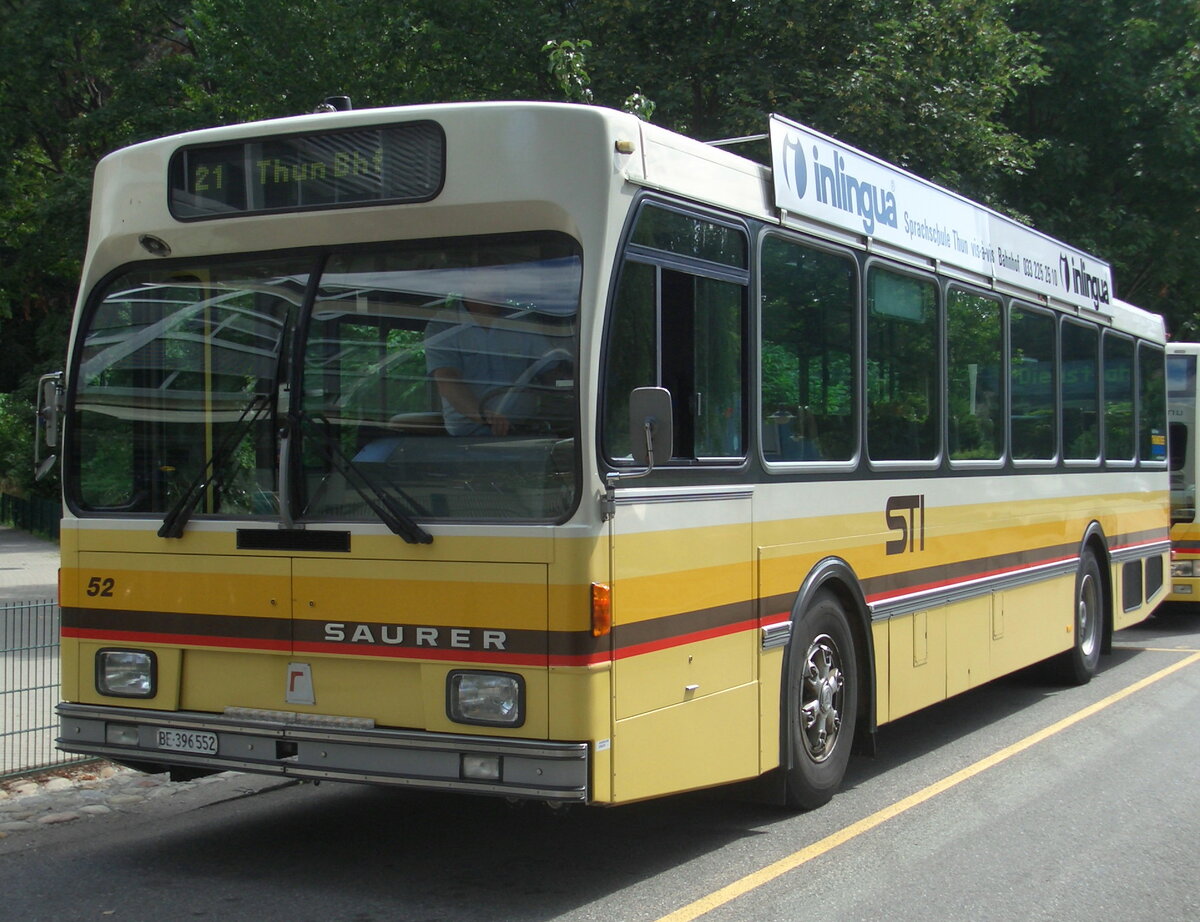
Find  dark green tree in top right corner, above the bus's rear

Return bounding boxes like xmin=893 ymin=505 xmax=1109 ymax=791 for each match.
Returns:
xmin=1006 ymin=0 xmax=1200 ymax=339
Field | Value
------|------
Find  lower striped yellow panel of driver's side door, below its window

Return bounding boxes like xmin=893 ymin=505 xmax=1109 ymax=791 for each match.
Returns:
xmin=611 ymin=487 xmax=758 ymax=801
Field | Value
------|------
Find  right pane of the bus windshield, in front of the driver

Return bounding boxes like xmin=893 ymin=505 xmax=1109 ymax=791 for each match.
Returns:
xmin=300 ymin=234 xmax=581 ymax=521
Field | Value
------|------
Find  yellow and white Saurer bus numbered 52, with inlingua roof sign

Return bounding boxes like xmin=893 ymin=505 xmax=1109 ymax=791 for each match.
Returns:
xmin=43 ymin=102 xmax=1169 ymax=808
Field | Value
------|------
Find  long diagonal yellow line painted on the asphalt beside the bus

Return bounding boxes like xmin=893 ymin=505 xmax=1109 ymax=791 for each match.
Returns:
xmin=658 ymin=651 xmax=1200 ymax=922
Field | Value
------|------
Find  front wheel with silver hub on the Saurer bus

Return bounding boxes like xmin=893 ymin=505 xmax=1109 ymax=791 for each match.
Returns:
xmin=784 ymin=589 xmax=859 ymax=810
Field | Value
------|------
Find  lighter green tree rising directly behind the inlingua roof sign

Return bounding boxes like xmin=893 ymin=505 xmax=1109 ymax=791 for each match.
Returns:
xmin=568 ymin=0 xmax=1042 ymax=198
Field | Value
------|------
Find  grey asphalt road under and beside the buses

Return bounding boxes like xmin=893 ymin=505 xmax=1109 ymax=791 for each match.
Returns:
xmin=0 ymin=605 xmax=1200 ymax=922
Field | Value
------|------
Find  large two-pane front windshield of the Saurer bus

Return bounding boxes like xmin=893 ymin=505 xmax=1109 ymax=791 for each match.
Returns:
xmin=67 ymin=234 xmax=581 ymax=525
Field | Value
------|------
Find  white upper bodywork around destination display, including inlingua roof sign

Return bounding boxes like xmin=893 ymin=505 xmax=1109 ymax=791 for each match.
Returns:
xmin=89 ymin=102 xmax=1163 ymax=339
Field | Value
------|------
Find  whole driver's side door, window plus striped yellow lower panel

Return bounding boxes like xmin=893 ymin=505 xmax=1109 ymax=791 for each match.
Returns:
xmin=604 ymin=248 xmax=760 ymax=801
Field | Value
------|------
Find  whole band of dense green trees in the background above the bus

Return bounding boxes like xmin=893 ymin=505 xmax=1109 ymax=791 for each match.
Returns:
xmin=0 ymin=0 xmax=1200 ymax=497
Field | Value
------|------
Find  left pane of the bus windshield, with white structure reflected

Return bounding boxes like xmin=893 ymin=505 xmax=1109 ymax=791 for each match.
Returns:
xmin=72 ymin=261 xmax=307 ymax=515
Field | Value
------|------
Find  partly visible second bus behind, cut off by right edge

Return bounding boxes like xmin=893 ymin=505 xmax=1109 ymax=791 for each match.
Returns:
xmin=1166 ymin=342 xmax=1200 ymax=600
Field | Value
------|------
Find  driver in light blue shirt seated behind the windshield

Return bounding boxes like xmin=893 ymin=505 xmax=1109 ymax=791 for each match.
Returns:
xmin=425 ymin=298 xmax=550 ymax=436
